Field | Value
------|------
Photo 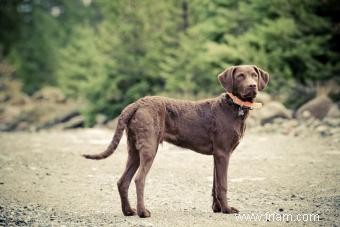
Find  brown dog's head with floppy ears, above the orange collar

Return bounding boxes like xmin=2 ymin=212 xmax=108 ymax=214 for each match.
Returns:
xmin=218 ymin=65 xmax=269 ymax=102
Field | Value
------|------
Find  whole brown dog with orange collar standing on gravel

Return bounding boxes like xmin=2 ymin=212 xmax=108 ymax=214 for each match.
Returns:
xmin=84 ymin=65 xmax=269 ymax=217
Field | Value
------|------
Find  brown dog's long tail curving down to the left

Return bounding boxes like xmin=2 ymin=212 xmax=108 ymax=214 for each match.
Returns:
xmin=83 ymin=103 xmax=138 ymax=160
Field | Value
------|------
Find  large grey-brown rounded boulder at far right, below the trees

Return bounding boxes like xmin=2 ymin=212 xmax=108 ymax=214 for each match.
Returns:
xmin=295 ymin=95 xmax=334 ymax=120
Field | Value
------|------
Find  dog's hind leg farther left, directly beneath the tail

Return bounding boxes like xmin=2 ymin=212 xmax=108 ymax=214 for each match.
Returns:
xmin=117 ymin=131 xmax=139 ymax=216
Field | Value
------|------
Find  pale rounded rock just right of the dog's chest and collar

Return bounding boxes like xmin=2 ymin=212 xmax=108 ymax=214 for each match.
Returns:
xmin=257 ymin=101 xmax=292 ymax=125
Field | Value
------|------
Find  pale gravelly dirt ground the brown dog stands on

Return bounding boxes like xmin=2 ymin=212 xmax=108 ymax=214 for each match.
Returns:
xmin=0 ymin=129 xmax=340 ymax=226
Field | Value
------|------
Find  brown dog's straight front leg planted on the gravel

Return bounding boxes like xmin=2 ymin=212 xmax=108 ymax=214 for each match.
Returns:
xmin=213 ymin=150 xmax=238 ymax=214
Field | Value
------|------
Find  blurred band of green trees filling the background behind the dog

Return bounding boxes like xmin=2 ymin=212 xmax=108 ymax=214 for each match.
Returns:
xmin=0 ymin=0 xmax=340 ymax=125
